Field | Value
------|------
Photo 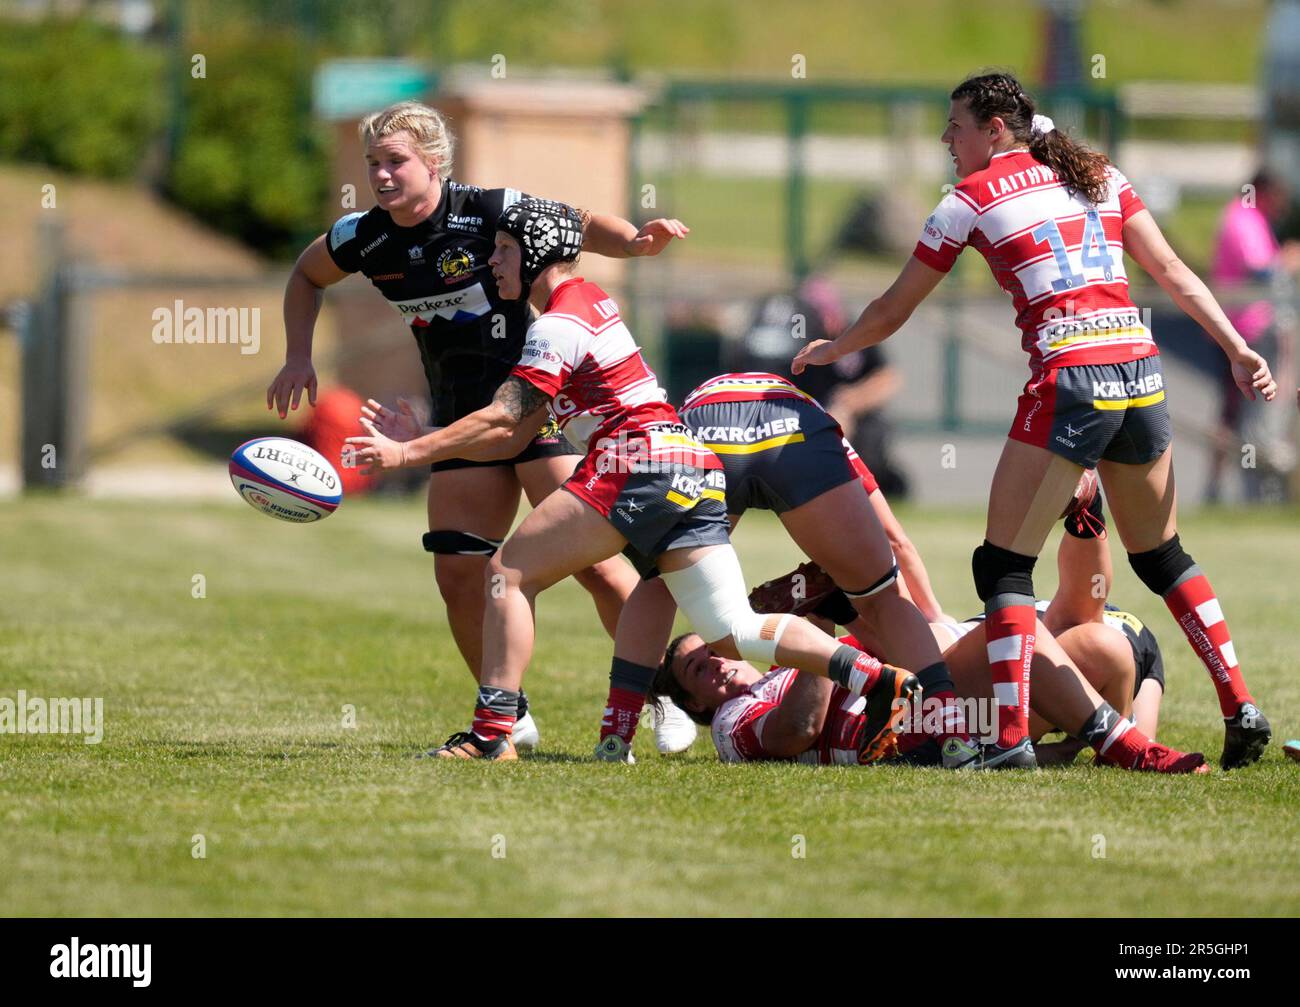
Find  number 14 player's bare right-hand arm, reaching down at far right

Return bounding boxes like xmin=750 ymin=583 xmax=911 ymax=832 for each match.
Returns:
xmin=1123 ymin=209 xmax=1278 ymax=402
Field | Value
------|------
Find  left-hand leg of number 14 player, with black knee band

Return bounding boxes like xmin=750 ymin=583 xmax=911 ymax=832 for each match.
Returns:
xmin=971 ymin=438 xmax=1084 ymax=765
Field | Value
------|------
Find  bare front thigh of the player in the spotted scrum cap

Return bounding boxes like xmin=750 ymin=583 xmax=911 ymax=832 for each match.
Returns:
xmin=491 ymin=491 xmax=628 ymax=591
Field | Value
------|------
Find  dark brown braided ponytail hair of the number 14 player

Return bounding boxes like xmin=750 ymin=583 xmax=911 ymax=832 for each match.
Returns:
xmin=949 ymin=70 xmax=1110 ymax=203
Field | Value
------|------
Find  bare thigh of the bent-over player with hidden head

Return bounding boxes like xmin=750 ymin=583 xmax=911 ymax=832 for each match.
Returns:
xmin=780 ymin=479 xmax=893 ymax=591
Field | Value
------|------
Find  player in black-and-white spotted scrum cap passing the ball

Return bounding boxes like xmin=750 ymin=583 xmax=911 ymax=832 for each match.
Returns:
xmin=350 ymin=200 xmax=910 ymax=759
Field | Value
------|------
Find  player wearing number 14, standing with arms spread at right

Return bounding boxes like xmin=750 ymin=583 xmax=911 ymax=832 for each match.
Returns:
xmin=793 ymin=73 xmax=1277 ymax=769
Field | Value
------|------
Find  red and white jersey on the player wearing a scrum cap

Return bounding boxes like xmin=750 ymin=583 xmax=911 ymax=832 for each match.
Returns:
xmin=511 ymin=277 xmax=681 ymax=449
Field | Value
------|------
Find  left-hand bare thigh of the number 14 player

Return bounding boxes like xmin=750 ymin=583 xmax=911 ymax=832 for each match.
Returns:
xmin=984 ymin=438 xmax=1086 ymax=556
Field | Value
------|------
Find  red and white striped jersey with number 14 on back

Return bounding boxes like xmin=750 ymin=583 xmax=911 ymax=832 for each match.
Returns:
xmin=913 ymin=151 xmax=1157 ymax=372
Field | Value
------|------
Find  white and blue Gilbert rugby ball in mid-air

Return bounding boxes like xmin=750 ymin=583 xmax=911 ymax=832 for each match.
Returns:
xmin=230 ymin=437 xmax=343 ymax=524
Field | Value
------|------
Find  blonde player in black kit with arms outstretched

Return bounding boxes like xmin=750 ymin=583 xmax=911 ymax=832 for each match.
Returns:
xmin=267 ymin=101 xmax=686 ymax=747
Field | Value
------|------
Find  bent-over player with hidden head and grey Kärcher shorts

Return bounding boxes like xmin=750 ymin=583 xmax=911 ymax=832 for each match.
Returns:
xmin=601 ymin=372 xmax=996 ymax=769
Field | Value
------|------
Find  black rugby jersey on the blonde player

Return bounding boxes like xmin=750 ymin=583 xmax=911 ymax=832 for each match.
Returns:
xmin=325 ymin=181 xmax=553 ymax=426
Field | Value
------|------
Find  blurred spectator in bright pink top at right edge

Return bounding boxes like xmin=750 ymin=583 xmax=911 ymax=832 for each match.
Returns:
xmin=1205 ymin=169 xmax=1300 ymax=503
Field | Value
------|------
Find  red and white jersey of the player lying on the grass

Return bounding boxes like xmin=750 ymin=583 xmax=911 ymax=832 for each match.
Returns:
xmin=711 ymin=668 xmax=867 ymax=765
